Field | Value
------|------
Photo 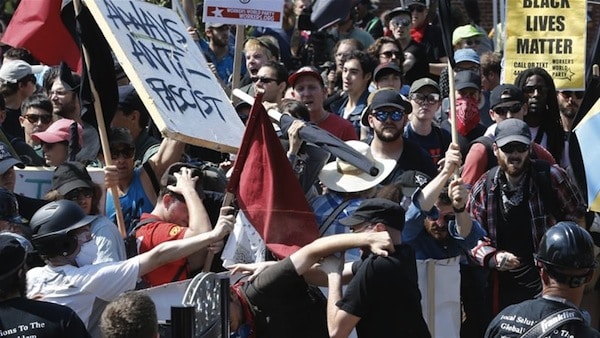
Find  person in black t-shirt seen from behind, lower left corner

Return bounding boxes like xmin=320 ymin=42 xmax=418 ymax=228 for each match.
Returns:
xmin=0 ymin=232 xmax=90 ymax=338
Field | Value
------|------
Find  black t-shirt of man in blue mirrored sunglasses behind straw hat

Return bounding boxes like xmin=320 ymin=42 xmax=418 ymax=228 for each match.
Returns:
xmin=381 ymin=138 xmax=437 ymax=185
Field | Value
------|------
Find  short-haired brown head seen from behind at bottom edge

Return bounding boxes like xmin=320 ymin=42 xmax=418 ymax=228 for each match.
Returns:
xmin=100 ymin=292 xmax=158 ymax=338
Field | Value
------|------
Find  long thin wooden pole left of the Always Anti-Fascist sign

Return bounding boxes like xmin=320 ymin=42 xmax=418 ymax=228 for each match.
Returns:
xmin=73 ymin=0 xmax=127 ymax=238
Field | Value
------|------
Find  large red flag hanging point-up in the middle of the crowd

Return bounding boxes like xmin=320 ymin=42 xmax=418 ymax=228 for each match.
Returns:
xmin=227 ymin=97 xmax=319 ymax=259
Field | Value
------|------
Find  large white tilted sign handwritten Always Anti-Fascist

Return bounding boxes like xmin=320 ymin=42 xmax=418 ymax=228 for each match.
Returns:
xmin=86 ymin=0 xmax=244 ymax=153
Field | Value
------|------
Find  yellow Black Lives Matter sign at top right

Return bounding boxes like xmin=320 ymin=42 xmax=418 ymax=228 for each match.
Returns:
xmin=504 ymin=0 xmax=587 ymax=90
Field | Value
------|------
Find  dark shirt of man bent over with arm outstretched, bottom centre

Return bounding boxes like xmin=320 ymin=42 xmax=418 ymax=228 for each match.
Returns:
xmin=242 ymin=258 xmax=329 ymax=338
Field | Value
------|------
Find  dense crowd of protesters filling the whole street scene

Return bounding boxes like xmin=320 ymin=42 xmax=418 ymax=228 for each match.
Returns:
xmin=0 ymin=0 xmax=600 ymax=338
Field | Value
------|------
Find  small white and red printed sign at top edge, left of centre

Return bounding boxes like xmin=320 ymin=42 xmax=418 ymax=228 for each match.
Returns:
xmin=202 ymin=0 xmax=284 ymax=28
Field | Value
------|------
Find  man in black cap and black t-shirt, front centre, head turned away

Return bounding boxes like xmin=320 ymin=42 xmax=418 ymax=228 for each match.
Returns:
xmin=320 ymin=198 xmax=431 ymax=337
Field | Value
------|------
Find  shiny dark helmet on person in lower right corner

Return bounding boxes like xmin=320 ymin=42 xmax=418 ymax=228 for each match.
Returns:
xmin=535 ymin=221 xmax=597 ymax=287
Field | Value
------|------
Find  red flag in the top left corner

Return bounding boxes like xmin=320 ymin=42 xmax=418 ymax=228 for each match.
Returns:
xmin=1 ymin=0 xmax=82 ymax=74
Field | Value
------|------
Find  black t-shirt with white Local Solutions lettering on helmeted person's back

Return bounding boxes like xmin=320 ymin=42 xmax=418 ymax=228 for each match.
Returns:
xmin=485 ymin=297 xmax=600 ymax=338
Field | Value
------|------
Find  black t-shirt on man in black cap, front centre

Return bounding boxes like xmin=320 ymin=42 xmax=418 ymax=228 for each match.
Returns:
xmin=336 ymin=244 xmax=431 ymax=338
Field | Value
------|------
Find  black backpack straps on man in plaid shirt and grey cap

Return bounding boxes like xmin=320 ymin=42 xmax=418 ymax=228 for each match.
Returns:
xmin=485 ymin=160 xmax=565 ymax=222
